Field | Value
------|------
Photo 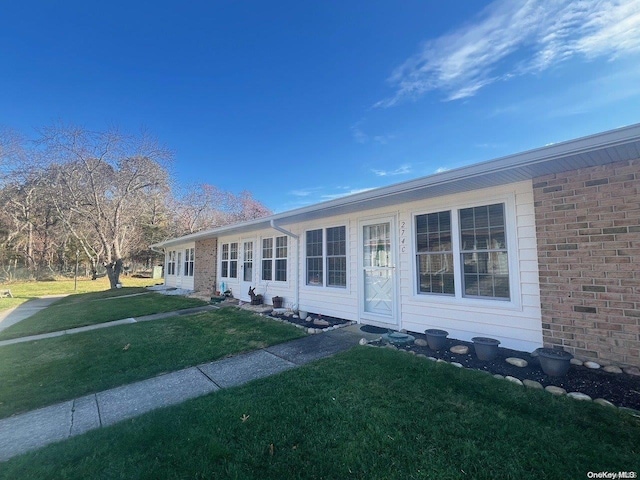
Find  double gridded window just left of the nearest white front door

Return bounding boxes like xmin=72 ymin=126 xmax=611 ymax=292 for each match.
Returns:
xmin=306 ymin=227 xmax=347 ymax=287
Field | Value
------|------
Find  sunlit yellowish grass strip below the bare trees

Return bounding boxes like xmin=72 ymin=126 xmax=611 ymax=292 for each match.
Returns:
xmin=0 ymin=277 xmax=158 ymax=312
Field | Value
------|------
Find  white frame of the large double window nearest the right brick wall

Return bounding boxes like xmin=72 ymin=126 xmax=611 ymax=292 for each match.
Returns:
xmin=411 ymin=193 xmax=522 ymax=311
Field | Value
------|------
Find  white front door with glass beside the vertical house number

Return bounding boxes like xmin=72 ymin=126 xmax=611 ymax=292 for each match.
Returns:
xmin=360 ymin=218 xmax=398 ymax=326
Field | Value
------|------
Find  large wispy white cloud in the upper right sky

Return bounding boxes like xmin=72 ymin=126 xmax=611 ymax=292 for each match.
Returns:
xmin=375 ymin=0 xmax=640 ymax=107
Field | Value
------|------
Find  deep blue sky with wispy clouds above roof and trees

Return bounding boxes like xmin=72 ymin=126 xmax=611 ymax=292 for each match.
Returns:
xmin=0 ymin=0 xmax=640 ymax=212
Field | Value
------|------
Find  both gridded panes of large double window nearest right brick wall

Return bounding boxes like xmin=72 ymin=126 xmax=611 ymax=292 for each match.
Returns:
xmin=415 ymin=203 xmax=511 ymax=300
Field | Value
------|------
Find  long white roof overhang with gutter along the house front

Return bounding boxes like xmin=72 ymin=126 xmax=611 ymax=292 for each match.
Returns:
xmin=151 ymin=124 xmax=640 ymax=248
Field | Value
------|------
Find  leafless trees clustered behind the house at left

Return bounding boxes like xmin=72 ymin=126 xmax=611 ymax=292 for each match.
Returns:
xmin=0 ymin=124 xmax=271 ymax=288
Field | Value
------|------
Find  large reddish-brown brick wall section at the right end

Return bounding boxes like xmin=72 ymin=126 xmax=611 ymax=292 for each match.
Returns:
xmin=533 ymin=159 xmax=640 ymax=366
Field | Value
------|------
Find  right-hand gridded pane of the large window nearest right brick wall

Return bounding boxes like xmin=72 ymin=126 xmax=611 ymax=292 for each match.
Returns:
xmin=460 ymin=203 xmax=509 ymax=299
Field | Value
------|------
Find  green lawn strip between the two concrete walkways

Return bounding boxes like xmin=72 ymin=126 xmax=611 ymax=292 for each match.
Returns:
xmin=0 ymin=306 xmax=304 ymax=418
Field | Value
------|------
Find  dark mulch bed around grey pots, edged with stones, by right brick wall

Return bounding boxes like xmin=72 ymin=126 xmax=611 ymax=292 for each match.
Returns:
xmin=370 ymin=332 xmax=640 ymax=410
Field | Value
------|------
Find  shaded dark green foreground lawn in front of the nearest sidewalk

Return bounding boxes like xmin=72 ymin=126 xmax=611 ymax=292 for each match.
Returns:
xmin=0 ymin=347 xmax=640 ymax=480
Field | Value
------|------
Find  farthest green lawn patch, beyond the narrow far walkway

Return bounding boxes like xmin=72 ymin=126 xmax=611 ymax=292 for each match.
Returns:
xmin=0 ymin=288 xmax=206 ymax=340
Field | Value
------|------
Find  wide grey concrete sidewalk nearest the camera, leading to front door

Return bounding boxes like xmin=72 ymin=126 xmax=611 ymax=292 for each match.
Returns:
xmin=0 ymin=325 xmax=378 ymax=461
